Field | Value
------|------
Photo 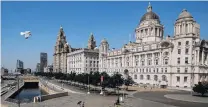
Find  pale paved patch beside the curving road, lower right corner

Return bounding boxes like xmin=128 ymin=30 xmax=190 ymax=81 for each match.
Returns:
xmin=164 ymin=94 xmax=208 ymax=103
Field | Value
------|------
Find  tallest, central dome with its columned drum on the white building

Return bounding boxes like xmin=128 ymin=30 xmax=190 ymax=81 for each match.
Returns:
xmin=135 ymin=3 xmax=164 ymax=43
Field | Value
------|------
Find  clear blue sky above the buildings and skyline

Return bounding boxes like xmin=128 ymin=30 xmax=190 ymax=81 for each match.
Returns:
xmin=1 ymin=1 xmax=208 ymax=69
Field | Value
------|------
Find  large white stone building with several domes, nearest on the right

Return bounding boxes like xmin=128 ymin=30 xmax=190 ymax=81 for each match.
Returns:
xmin=99 ymin=4 xmax=208 ymax=89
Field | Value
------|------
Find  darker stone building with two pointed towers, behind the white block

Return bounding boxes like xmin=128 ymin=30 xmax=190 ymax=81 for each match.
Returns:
xmin=53 ymin=26 xmax=96 ymax=73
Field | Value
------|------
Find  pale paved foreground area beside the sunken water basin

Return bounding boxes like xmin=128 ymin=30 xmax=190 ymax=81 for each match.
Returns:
xmin=6 ymin=93 xmax=117 ymax=107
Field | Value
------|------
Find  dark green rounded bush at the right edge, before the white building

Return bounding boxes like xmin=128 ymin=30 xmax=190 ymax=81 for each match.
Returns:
xmin=193 ymin=82 xmax=207 ymax=96
